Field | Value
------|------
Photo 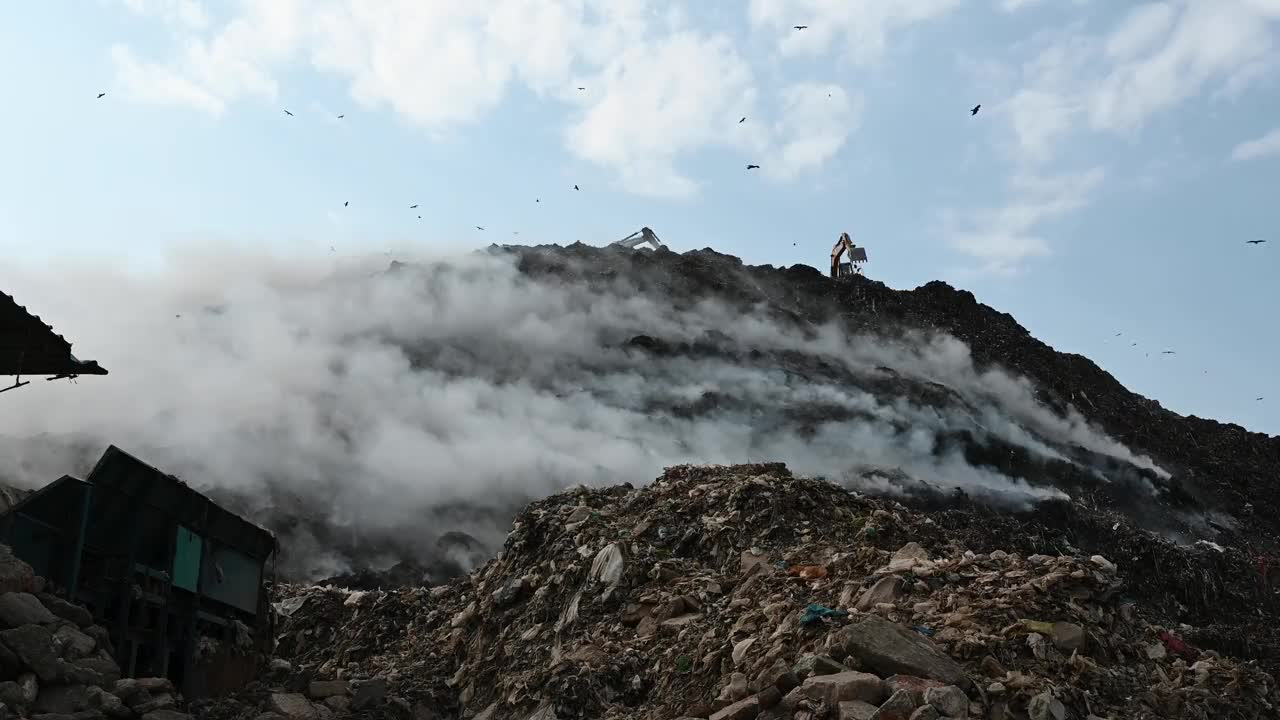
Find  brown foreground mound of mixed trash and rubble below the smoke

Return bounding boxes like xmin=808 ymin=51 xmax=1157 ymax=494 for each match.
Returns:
xmin=209 ymin=465 xmax=1280 ymax=720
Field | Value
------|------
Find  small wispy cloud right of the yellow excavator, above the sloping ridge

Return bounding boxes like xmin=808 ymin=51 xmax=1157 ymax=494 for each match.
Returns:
xmin=948 ymin=168 xmax=1105 ymax=274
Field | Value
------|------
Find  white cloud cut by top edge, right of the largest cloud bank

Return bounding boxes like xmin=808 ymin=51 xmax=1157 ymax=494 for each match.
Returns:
xmin=748 ymin=0 xmax=960 ymax=64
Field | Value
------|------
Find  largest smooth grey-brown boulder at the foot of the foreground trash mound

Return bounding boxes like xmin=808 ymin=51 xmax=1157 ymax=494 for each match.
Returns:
xmin=841 ymin=615 xmax=969 ymax=687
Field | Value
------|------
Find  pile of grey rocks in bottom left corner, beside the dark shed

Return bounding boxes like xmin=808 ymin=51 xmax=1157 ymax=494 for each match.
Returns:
xmin=0 ymin=544 xmax=191 ymax=720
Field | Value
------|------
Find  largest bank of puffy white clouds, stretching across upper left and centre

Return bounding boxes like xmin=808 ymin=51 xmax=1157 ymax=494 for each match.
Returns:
xmin=111 ymin=0 xmax=880 ymax=196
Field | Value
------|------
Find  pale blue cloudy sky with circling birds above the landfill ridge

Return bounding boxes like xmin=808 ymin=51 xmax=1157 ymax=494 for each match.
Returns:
xmin=0 ymin=0 xmax=1280 ymax=434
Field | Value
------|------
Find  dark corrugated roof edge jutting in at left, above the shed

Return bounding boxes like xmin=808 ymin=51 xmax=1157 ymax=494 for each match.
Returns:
xmin=0 ymin=292 xmax=106 ymax=375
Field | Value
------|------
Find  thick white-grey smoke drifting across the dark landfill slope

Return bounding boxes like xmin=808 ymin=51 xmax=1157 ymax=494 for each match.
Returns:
xmin=0 ymin=243 xmax=1167 ymax=577
